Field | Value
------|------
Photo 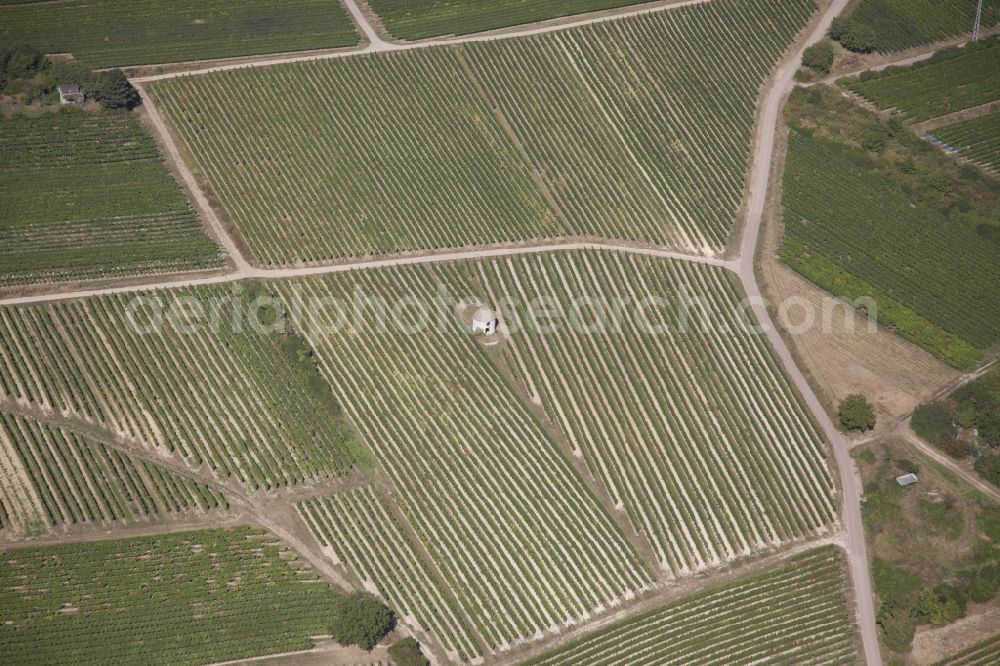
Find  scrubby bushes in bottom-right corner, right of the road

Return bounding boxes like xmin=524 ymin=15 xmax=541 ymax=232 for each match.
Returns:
xmin=872 ymin=509 xmax=1000 ymax=652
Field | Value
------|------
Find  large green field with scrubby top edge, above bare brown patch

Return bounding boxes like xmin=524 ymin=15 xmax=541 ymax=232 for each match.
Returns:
xmin=781 ymin=91 xmax=1000 ymax=368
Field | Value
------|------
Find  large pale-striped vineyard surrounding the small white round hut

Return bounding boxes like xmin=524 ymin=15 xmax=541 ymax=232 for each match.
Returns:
xmin=273 ymin=252 xmax=834 ymax=655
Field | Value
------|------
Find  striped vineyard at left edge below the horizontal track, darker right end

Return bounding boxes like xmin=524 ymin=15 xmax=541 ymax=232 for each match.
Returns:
xmin=0 ymin=285 xmax=354 ymax=489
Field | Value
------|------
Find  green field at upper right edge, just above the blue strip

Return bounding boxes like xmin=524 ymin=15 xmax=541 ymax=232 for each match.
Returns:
xmin=843 ymin=37 xmax=1000 ymax=122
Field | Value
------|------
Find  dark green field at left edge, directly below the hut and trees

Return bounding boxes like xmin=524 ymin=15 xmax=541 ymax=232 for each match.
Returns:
xmin=0 ymin=111 xmax=221 ymax=286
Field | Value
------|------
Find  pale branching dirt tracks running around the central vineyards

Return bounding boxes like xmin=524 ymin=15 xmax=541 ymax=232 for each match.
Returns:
xmin=0 ymin=0 xmax=900 ymax=666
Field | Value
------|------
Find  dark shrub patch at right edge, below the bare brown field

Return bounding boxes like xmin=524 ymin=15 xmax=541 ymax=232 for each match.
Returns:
xmin=911 ymin=369 xmax=1000 ymax=486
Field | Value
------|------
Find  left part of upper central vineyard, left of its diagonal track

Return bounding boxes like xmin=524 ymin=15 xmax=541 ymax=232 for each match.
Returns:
xmin=152 ymin=49 xmax=566 ymax=264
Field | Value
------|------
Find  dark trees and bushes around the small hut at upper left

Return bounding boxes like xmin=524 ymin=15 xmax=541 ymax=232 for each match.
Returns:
xmin=0 ymin=44 xmax=142 ymax=110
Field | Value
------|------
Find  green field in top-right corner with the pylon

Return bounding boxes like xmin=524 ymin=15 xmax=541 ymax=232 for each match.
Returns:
xmin=848 ymin=0 xmax=1000 ymax=52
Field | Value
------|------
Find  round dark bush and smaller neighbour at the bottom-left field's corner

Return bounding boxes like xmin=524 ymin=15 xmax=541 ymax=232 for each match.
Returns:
xmin=330 ymin=592 xmax=430 ymax=666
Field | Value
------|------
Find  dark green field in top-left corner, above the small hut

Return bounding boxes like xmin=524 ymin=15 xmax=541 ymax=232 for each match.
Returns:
xmin=0 ymin=0 xmax=358 ymax=67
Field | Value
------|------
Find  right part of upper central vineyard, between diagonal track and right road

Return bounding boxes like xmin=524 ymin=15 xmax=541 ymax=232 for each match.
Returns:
xmin=466 ymin=0 xmax=816 ymax=254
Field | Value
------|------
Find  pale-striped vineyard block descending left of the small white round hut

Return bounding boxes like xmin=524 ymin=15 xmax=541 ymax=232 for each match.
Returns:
xmin=274 ymin=266 xmax=652 ymax=651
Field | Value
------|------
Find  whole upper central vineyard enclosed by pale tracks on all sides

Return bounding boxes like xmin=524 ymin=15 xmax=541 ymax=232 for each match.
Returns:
xmin=151 ymin=0 xmax=815 ymax=265
